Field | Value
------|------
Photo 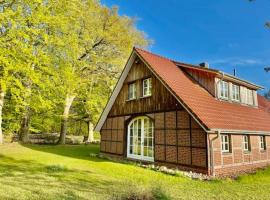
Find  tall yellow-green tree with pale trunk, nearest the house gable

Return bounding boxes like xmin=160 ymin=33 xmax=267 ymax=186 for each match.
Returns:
xmin=52 ymin=1 xmax=148 ymax=144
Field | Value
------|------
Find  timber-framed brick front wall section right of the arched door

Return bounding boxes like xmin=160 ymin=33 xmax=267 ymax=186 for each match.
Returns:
xmin=154 ymin=110 xmax=207 ymax=169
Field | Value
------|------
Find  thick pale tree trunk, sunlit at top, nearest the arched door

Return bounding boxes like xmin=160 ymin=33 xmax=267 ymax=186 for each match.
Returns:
xmin=58 ymin=95 xmax=75 ymax=144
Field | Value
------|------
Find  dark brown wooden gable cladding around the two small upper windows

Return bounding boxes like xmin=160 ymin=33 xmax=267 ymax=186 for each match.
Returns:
xmin=108 ymin=58 xmax=182 ymax=117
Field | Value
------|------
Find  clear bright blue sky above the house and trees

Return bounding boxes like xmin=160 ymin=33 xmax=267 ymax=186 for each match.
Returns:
xmin=101 ymin=0 xmax=270 ymax=92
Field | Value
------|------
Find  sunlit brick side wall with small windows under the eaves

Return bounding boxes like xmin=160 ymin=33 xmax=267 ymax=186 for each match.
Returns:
xmin=209 ymin=134 xmax=270 ymax=176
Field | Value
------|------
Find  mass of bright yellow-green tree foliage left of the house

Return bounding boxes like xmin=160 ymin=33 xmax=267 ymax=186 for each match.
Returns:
xmin=0 ymin=0 xmax=149 ymax=137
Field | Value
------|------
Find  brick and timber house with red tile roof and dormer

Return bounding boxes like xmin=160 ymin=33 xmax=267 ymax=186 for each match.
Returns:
xmin=95 ymin=48 xmax=270 ymax=176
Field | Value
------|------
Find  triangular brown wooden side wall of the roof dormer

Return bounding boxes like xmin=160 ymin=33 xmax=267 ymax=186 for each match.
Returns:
xmin=185 ymin=69 xmax=216 ymax=96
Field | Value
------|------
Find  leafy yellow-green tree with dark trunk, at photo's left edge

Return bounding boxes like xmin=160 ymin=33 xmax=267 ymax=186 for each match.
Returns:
xmin=0 ymin=0 xmax=65 ymax=142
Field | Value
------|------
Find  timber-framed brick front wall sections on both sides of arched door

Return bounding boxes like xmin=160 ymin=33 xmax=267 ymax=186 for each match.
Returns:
xmin=101 ymin=110 xmax=207 ymax=171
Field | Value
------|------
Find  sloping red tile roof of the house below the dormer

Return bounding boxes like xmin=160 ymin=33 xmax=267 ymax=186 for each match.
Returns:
xmin=135 ymin=48 xmax=270 ymax=132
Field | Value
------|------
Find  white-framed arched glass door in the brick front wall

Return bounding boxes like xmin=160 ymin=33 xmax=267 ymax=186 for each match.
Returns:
xmin=127 ymin=117 xmax=154 ymax=161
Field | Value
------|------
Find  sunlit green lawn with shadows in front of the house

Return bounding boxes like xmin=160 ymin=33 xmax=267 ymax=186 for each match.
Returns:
xmin=0 ymin=143 xmax=270 ymax=200
